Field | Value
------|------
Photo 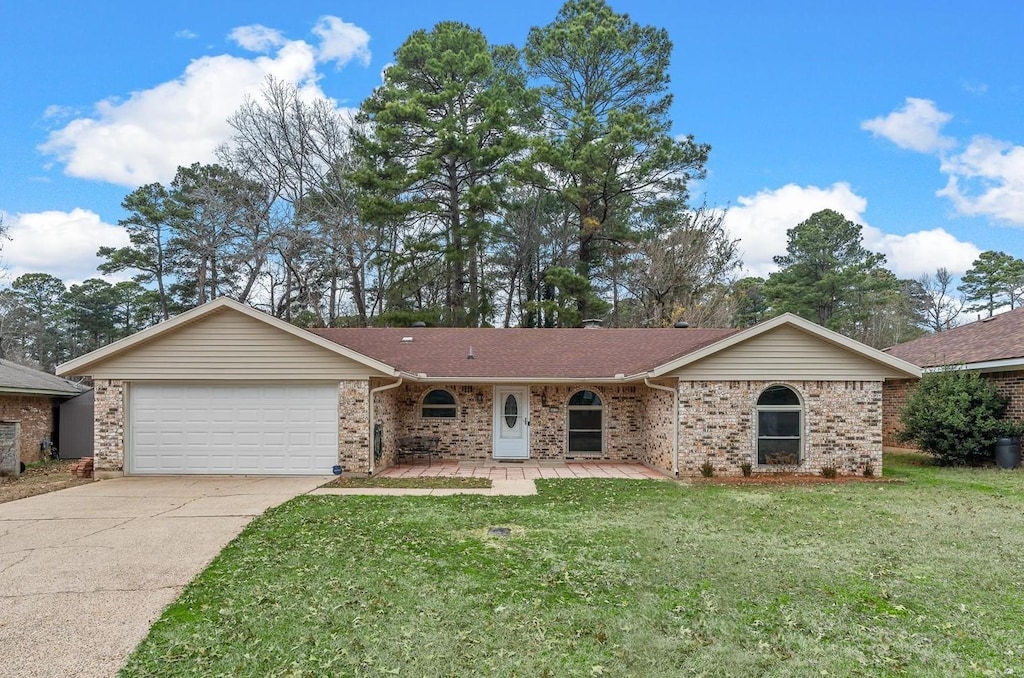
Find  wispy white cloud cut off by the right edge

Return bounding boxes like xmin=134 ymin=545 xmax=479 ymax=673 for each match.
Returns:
xmin=936 ymin=136 xmax=1024 ymax=225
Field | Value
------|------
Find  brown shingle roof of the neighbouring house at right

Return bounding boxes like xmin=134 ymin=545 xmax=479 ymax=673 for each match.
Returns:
xmin=886 ymin=308 xmax=1024 ymax=368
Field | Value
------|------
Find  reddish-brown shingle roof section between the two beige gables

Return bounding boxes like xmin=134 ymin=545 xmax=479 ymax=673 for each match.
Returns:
xmin=310 ymin=328 xmax=739 ymax=379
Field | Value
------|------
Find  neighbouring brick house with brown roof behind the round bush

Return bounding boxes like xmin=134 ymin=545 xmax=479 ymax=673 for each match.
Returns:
xmin=882 ymin=308 xmax=1024 ymax=447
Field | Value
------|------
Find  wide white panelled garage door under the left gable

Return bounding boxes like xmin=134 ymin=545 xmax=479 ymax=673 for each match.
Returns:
xmin=128 ymin=384 xmax=338 ymax=475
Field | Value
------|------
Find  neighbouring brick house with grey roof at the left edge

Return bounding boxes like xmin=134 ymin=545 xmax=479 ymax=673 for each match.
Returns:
xmin=0 ymin=359 xmax=87 ymax=464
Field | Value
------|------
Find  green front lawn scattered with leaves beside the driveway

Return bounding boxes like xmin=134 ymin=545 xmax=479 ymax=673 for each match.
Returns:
xmin=124 ymin=456 xmax=1024 ymax=677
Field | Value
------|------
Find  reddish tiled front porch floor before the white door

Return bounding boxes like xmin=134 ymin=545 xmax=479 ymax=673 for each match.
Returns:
xmin=377 ymin=461 xmax=669 ymax=480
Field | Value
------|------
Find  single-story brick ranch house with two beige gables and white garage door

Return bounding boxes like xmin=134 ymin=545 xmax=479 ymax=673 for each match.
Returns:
xmin=58 ymin=298 xmax=921 ymax=477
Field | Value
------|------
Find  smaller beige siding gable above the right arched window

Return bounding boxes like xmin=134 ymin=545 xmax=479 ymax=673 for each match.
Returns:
xmin=666 ymin=326 xmax=904 ymax=381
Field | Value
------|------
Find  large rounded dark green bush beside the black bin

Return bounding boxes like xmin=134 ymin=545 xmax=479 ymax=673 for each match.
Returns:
xmin=898 ymin=368 xmax=1008 ymax=466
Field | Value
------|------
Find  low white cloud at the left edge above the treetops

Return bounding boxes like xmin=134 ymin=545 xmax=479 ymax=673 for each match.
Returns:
xmin=2 ymin=213 xmax=128 ymax=286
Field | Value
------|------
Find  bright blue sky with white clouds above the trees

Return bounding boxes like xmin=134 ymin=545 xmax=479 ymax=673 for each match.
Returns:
xmin=0 ymin=0 xmax=1024 ymax=283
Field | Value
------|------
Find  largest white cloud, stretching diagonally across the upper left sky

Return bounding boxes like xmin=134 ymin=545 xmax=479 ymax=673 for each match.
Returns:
xmin=40 ymin=17 xmax=369 ymax=187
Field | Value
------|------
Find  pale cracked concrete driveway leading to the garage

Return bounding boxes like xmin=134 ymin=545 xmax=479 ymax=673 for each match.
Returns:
xmin=0 ymin=476 xmax=329 ymax=676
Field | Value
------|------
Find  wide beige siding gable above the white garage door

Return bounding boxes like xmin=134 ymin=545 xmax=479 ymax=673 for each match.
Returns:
xmin=89 ymin=309 xmax=381 ymax=381
